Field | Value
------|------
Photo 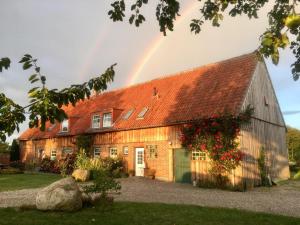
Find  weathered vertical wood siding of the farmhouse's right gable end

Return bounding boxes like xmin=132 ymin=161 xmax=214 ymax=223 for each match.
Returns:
xmin=240 ymin=63 xmax=289 ymax=186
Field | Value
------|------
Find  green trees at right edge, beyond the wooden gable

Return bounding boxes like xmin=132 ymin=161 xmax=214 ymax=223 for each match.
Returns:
xmin=287 ymin=127 xmax=300 ymax=164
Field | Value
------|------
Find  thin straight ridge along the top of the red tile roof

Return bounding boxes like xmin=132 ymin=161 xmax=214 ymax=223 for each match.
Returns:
xmin=95 ymin=51 xmax=256 ymax=98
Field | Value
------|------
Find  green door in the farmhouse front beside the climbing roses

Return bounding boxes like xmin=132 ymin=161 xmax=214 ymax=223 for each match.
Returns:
xmin=174 ymin=149 xmax=192 ymax=183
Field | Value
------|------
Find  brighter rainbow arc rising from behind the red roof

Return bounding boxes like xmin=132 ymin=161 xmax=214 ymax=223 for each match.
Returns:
xmin=126 ymin=1 xmax=199 ymax=86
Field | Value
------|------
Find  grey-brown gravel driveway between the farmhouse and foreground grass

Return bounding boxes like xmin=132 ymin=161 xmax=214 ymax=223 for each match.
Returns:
xmin=0 ymin=177 xmax=300 ymax=217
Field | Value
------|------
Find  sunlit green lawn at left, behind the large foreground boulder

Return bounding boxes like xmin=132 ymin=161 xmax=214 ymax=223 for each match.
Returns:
xmin=0 ymin=173 xmax=62 ymax=192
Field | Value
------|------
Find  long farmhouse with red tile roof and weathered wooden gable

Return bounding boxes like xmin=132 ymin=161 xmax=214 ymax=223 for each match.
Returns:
xmin=19 ymin=53 xmax=290 ymax=186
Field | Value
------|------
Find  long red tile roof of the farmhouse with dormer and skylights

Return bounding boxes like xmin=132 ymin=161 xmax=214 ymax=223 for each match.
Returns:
xmin=19 ymin=53 xmax=257 ymax=140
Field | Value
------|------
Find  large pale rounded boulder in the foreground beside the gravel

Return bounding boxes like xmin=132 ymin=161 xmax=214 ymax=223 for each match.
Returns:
xmin=36 ymin=177 xmax=82 ymax=211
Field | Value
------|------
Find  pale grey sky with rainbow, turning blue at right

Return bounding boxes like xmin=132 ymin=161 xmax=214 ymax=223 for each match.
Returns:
xmin=0 ymin=0 xmax=300 ymax=141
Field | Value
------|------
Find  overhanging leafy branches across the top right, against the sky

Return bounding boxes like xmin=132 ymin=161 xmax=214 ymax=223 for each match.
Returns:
xmin=108 ymin=0 xmax=300 ymax=80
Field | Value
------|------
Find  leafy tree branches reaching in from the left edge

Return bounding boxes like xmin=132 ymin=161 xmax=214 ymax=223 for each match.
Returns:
xmin=0 ymin=54 xmax=116 ymax=141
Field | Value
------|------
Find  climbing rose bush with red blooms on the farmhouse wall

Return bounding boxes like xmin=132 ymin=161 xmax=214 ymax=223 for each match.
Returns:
xmin=181 ymin=106 xmax=253 ymax=176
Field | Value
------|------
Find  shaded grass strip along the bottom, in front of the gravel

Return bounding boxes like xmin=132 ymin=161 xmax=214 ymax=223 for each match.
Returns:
xmin=0 ymin=202 xmax=300 ymax=225
